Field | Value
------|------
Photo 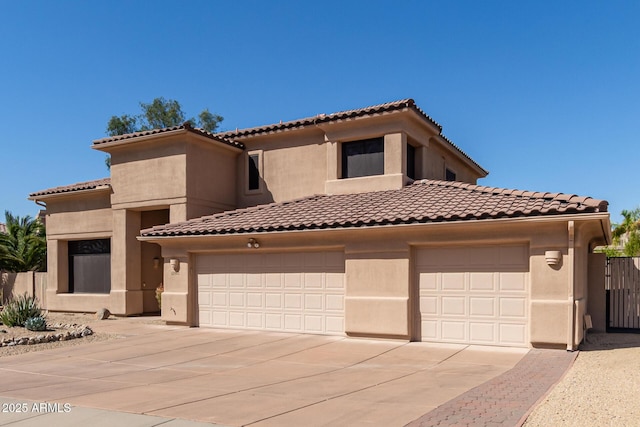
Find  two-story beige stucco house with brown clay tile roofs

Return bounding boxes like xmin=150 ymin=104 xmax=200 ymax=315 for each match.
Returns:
xmin=30 ymin=99 xmax=610 ymax=349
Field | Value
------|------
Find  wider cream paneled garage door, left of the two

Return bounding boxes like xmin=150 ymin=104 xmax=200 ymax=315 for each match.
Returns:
xmin=196 ymin=252 xmax=344 ymax=335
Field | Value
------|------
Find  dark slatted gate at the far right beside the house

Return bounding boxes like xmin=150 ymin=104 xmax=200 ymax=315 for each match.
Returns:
xmin=605 ymin=257 xmax=640 ymax=333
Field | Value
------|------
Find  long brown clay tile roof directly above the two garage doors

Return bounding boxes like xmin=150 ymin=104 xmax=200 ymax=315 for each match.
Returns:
xmin=141 ymin=180 xmax=607 ymax=237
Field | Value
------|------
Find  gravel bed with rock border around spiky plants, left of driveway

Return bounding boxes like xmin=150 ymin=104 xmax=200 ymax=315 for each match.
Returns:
xmin=0 ymin=313 xmax=118 ymax=358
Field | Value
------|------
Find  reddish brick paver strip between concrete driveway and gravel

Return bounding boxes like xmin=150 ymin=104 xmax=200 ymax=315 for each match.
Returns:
xmin=407 ymin=349 xmax=578 ymax=427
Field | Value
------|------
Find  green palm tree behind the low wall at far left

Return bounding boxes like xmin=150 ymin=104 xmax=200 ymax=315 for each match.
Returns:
xmin=0 ymin=211 xmax=47 ymax=273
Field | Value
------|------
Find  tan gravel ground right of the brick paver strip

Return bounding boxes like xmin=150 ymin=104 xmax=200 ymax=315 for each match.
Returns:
xmin=524 ymin=334 xmax=640 ymax=427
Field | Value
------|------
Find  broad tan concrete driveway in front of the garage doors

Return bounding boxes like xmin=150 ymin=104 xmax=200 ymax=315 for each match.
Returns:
xmin=0 ymin=318 xmax=527 ymax=426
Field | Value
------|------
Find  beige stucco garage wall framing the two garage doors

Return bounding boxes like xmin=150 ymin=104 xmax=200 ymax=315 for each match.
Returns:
xmin=149 ymin=220 xmax=608 ymax=348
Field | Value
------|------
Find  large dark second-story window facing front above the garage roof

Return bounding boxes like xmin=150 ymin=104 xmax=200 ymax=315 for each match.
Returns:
xmin=342 ymin=138 xmax=384 ymax=178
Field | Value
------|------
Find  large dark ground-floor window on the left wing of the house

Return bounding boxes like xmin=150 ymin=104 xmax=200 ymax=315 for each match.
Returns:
xmin=68 ymin=239 xmax=111 ymax=294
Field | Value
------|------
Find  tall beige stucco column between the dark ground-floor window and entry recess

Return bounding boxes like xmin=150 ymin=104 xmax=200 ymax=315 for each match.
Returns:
xmin=109 ymin=209 xmax=143 ymax=315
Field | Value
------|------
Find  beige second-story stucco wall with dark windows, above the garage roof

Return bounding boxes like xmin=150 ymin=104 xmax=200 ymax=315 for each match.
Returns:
xmin=230 ymin=107 xmax=486 ymax=207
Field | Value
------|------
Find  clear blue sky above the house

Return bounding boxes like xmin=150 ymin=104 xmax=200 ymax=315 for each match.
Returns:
xmin=0 ymin=0 xmax=640 ymax=221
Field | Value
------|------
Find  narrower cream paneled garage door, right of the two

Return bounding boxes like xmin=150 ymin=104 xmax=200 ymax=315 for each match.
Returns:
xmin=416 ymin=245 xmax=529 ymax=347
